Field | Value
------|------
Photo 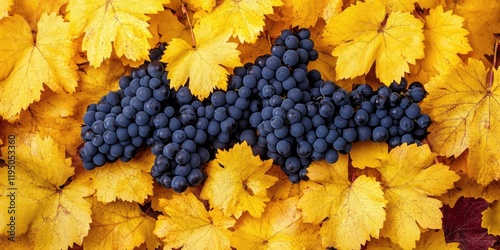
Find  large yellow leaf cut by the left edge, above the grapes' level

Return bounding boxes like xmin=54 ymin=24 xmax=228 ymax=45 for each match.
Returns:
xmin=0 ymin=13 xmax=78 ymax=118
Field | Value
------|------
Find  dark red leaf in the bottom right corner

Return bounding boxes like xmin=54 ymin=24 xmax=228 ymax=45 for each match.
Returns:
xmin=442 ymin=197 xmax=498 ymax=249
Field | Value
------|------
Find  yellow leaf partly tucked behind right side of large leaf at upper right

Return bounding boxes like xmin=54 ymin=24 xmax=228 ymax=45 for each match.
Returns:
xmin=419 ymin=6 xmax=472 ymax=82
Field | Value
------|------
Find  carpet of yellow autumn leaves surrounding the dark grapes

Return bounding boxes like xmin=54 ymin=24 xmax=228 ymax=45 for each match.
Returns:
xmin=0 ymin=0 xmax=500 ymax=249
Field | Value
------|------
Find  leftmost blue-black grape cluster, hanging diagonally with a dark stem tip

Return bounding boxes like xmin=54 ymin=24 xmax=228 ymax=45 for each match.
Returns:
xmin=79 ymin=44 xmax=170 ymax=170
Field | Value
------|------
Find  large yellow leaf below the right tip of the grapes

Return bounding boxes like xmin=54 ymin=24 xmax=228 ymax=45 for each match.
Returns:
xmin=377 ymin=144 xmax=459 ymax=249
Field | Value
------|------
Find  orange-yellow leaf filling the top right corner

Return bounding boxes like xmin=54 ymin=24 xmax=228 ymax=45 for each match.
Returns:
xmin=447 ymin=0 xmax=500 ymax=63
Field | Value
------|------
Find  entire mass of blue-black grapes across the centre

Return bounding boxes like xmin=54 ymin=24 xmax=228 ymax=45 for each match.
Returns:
xmin=80 ymin=26 xmax=431 ymax=192
